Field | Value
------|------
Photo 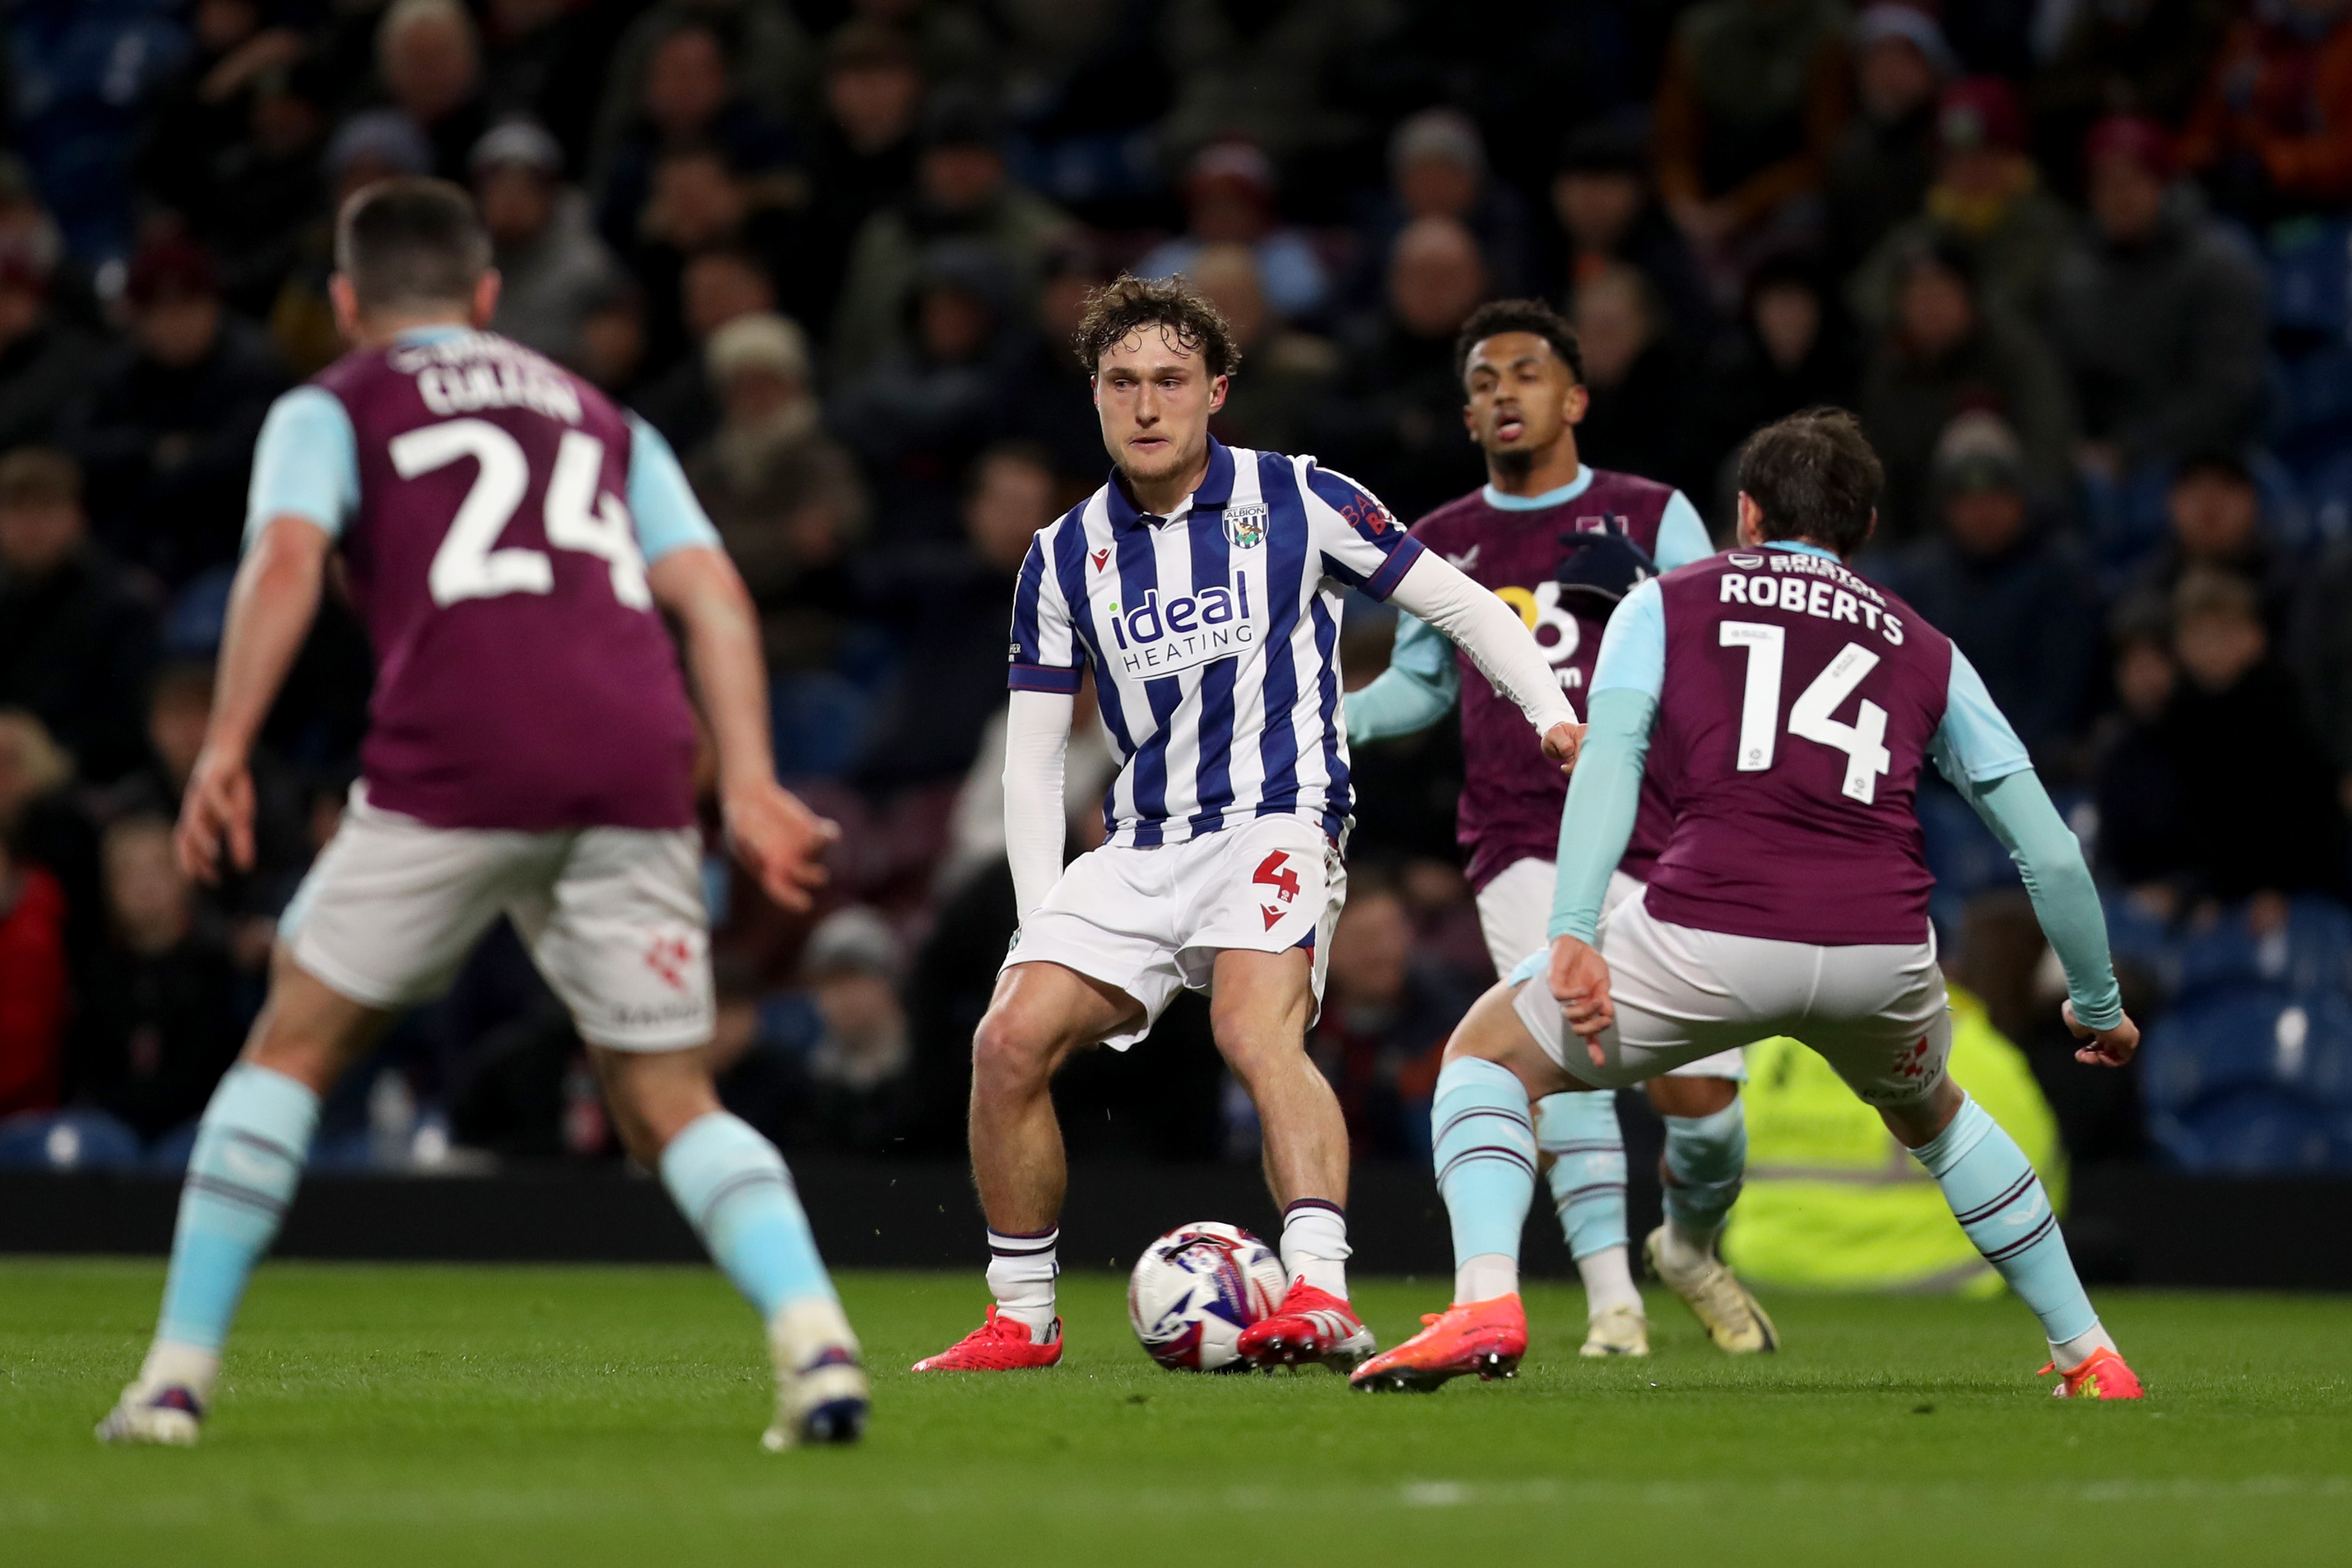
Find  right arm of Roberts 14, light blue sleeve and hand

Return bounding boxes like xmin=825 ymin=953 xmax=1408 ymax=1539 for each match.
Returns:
xmin=1934 ymin=649 xmax=2141 ymax=1067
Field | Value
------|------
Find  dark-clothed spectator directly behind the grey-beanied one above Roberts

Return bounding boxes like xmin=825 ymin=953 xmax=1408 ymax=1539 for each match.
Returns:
xmin=1860 ymin=238 xmax=2074 ymax=545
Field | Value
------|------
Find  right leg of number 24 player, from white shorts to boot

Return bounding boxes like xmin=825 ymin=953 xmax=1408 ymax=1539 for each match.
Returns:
xmin=508 ymin=827 xmax=866 ymax=1448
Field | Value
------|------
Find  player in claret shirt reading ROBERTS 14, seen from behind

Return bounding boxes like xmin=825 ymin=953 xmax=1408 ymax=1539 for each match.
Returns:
xmin=1355 ymin=409 xmax=2141 ymax=1399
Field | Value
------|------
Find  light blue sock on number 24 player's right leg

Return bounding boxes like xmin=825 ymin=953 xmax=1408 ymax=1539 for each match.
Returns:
xmin=661 ymin=1109 xmax=835 ymax=1323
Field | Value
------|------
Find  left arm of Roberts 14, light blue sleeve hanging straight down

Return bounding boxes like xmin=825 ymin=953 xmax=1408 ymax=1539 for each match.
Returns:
xmin=1548 ymin=578 xmax=1665 ymax=1065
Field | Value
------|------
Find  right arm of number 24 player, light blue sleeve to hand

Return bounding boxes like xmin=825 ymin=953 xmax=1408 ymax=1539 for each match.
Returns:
xmin=628 ymin=416 xmax=842 ymax=909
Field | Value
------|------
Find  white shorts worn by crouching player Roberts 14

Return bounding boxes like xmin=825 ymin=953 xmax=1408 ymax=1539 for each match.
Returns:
xmin=1513 ymin=888 xmax=1952 ymax=1105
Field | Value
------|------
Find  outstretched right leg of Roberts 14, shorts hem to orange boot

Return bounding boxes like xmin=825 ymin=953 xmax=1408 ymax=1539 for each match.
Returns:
xmin=1809 ymin=943 xmax=2141 ymax=1399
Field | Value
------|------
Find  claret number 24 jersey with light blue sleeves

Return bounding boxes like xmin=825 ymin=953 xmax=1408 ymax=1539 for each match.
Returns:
xmin=247 ymin=327 xmax=717 ymax=832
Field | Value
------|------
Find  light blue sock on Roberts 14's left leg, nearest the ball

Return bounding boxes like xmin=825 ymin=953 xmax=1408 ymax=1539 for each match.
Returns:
xmin=1430 ymin=1055 xmax=1536 ymax=1300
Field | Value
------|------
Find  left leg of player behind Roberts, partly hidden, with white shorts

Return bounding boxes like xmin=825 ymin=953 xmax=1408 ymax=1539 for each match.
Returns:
xmin=1477 ymin=860 xmax=1649 ymax=1357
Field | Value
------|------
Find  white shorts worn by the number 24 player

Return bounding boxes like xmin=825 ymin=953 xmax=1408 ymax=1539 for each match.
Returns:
xmin=278 ymin=785 xmax=715 ymax=1051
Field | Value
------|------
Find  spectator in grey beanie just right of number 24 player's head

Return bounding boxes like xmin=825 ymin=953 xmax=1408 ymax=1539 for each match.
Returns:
xmin=473 ymin=120 xmax=621 ymax=367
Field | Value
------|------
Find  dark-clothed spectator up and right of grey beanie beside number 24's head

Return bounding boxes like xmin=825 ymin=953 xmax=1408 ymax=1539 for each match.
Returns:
xmin=593 ymin=21 xmax=802 ymax=259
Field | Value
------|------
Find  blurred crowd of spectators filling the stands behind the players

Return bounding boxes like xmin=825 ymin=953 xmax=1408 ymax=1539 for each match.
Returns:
xmin=0 ymin=0 xmax=2352 ymax=1164
